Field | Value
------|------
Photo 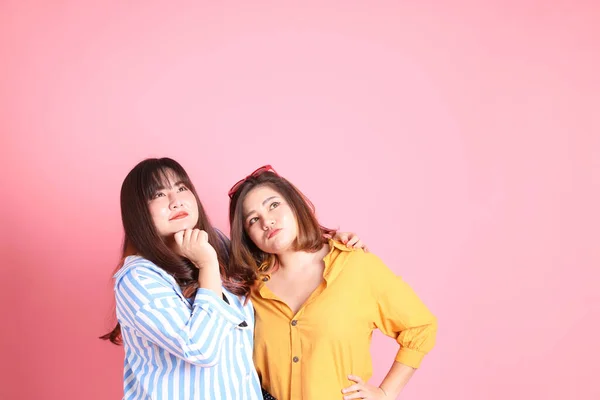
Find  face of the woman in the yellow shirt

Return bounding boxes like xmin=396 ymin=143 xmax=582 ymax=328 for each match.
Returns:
xmin=242 ymin=186 xmax=298 ymax=254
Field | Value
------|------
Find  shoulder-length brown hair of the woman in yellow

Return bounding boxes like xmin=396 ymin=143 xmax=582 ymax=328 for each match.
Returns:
xmin=229 ymin=171 xmax=336 ymax=279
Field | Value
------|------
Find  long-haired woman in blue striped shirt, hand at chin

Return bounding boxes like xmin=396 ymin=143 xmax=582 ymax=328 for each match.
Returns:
xmin=103 ymin=158 xmax=262 ymax=400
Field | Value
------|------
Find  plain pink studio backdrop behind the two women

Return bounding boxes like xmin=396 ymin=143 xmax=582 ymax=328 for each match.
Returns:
xmin=0 ymin=0 xmax=600 ymax=400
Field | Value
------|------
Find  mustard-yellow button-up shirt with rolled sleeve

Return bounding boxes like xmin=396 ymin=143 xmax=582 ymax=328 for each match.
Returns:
xmin=252 ymin=240 xmax=437 ymax=400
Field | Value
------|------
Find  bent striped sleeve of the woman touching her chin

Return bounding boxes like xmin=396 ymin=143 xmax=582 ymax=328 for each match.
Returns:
xmin=115 ymin=268 xmax=244 ymax=366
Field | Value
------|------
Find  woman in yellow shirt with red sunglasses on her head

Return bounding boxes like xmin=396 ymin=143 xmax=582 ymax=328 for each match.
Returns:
xmin=229 ymin=166 xmax=437 ymax=400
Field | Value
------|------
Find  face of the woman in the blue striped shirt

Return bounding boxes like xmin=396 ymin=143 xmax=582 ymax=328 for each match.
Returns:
xmin=148 ymin=171 xmax=198 ymax=238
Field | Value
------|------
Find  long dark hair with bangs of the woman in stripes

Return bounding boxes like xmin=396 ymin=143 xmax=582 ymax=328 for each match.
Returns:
xmin=100 ymin=158 xmax=249 ymax=344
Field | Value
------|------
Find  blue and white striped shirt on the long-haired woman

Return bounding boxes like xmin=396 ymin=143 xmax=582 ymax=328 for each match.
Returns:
xmin=115 ymin=256 xmax=262 ymax=400
